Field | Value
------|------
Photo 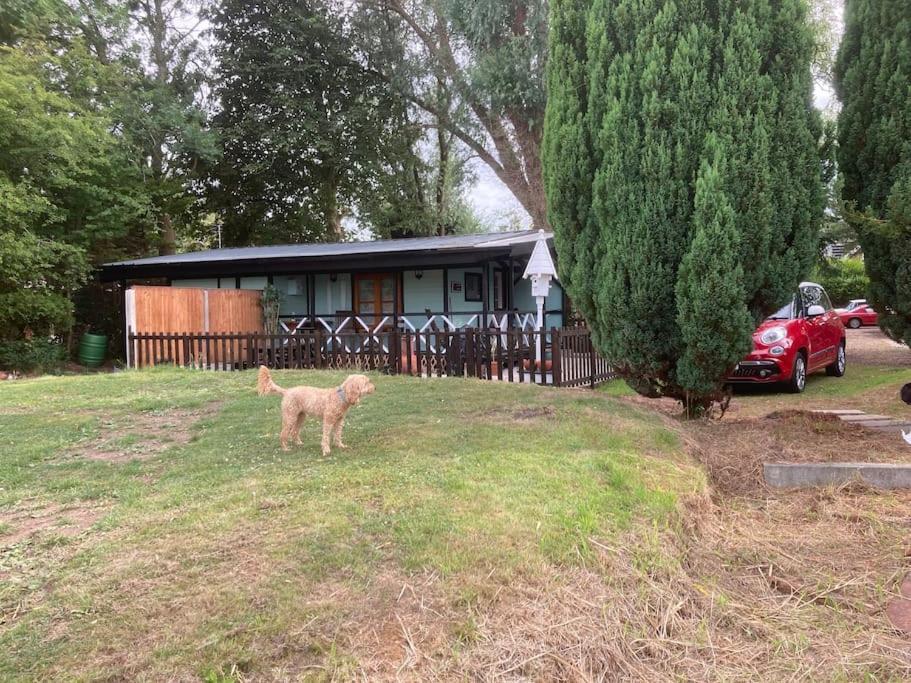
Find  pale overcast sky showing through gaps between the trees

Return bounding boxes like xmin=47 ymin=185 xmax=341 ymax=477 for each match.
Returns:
xmin=468 ymin=0 xmax=848 ymax=228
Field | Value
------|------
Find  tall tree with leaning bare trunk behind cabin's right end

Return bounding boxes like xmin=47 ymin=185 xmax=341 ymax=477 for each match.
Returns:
xmin=357 ymin=0 xmax=547 ymax=228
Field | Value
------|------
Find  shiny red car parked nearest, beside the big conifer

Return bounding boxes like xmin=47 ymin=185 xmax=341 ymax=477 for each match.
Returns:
xmin=728 ymin=282 xmax=846 ymax=393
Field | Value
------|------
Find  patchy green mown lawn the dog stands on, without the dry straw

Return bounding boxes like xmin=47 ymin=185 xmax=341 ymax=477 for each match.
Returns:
xmin=0 ymin=370 xmax=705 ymax=680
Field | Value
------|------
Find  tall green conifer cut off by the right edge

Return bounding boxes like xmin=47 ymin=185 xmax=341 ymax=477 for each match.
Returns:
xmin=835 ymin=0 xmax=911 ymax=345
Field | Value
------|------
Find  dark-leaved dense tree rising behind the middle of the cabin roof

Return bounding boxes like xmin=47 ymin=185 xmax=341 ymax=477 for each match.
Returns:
xmin=212 ymin=0 xmax=415 ymax=244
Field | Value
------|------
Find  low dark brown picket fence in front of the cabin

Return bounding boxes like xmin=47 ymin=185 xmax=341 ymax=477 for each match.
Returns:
xmin=128 ymin=327 xmax=614 ymax=387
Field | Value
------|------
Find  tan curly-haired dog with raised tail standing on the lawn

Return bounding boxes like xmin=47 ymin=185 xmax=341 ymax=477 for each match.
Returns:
xmin=256 ymin=365 xmax=376 ymax=455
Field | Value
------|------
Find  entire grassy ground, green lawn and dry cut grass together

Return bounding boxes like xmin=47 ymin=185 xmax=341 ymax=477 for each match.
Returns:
xmin=0 ymin=363 xmax=911 ymax=682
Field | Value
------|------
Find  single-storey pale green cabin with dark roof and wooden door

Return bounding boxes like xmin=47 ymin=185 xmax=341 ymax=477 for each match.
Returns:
xmin=100 ymin=230 xmax=567 ymax=340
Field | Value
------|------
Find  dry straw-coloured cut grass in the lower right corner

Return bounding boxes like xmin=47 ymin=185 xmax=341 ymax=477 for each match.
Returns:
xmin=425 ymin=491 xmax=911 ymax=681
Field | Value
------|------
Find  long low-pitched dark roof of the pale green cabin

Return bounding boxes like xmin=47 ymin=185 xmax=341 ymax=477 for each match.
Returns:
xmin=101 ymin=230 xmax=550 ymax=280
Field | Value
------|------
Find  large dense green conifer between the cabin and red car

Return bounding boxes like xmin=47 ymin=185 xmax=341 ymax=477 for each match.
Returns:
xmin=543 ymin=0 xmax=824 ymax=408
